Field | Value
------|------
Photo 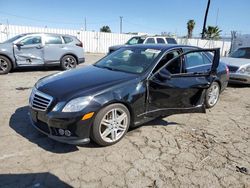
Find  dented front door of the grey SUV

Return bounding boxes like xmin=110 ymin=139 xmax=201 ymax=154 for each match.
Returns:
xmin=13 ymin=35 xmax=44 ymax=65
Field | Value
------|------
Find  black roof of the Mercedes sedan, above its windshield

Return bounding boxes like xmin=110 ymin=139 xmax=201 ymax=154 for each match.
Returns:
xmin=122 ymin=44 xmax=198 ymax=51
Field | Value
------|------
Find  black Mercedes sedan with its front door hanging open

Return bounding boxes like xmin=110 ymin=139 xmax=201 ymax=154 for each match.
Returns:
xmin=29 ymin=45 xmax=228 ymax=146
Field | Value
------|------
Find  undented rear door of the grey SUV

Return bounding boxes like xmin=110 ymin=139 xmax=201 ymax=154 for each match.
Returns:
xmin=44 ymin=34 xmax=67 ymax=64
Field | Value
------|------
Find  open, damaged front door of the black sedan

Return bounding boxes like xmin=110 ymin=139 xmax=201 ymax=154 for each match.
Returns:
xmin=146 ymin=49 xmax=220 ymax=117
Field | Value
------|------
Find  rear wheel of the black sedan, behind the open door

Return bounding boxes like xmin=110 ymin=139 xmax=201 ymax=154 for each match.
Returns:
xmin=205 ymin=82 xmax=220 ymax=108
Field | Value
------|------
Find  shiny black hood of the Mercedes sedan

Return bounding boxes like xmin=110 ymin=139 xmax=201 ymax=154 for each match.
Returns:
xmin=36 ymin=65 xmax=138 ymax=101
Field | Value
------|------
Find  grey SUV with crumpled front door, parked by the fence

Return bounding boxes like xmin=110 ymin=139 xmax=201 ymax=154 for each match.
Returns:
xmin=0 ymin=33 xmax=85 ymax=74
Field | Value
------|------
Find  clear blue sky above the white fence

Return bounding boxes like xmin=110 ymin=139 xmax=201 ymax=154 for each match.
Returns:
xmin=0 ymin=0 xmax=250 ymax=36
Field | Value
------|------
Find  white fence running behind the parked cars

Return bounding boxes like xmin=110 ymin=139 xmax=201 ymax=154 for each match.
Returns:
xmin=0 ymin=25 xmax=231 ymax=55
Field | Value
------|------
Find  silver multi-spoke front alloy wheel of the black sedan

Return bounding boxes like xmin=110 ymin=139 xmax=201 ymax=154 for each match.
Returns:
xmin=99 ymin=108 xmax=129 ymax=143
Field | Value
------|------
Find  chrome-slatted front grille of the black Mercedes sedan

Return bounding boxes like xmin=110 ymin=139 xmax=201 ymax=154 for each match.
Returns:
xmin=30 ymin=89 xmax=53 ymax=111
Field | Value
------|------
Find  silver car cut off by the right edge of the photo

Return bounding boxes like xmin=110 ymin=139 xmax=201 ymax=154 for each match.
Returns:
xmin=221 ymin=47 xmax=250 ymax=84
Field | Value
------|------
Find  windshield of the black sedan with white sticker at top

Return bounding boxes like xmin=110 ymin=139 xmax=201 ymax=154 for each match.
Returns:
xmin=94 ymin=48 xmax=161 ymax=74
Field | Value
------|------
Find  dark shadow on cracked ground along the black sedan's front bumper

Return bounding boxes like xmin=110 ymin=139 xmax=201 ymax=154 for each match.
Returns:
xmin=9 ymin=106 xmax=78 ymax=153
